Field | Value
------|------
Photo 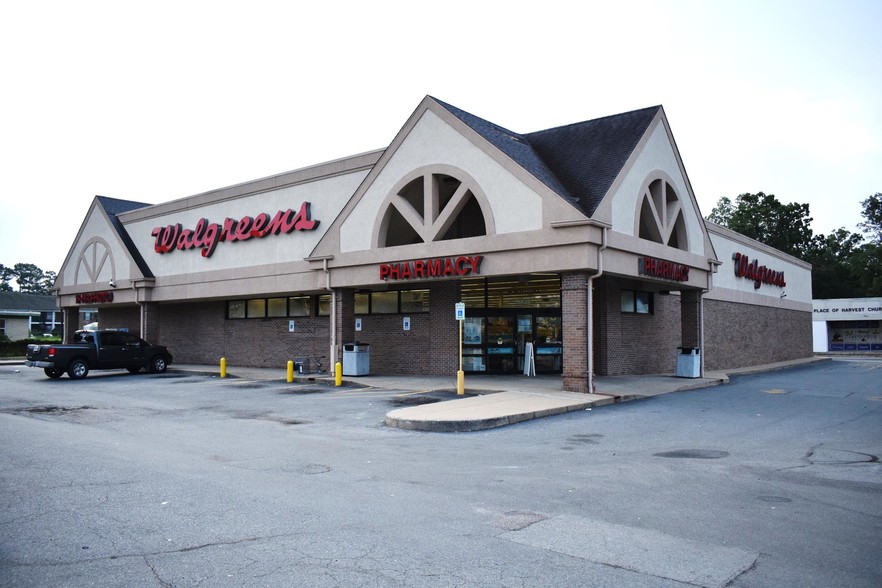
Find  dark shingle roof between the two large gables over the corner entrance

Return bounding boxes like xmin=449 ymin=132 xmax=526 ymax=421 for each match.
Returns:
xmin=433 ymin=98 xmax=661 ymax=216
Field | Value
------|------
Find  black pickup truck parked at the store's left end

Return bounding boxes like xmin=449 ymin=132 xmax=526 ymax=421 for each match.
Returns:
xmin=25 ymin=331 xmax=172 ymax=380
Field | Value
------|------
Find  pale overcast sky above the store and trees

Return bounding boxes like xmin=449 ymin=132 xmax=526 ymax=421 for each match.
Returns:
xmin=0 ymin=0 xmax=882 ymax=272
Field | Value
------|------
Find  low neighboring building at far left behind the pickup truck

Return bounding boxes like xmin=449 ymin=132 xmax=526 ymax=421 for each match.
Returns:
xmin=0 ymin=292 xmax=62 ymax=341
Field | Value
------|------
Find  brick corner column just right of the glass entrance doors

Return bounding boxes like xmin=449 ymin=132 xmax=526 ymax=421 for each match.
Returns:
xmin=560 ymin=273 xmax=591 ymax=392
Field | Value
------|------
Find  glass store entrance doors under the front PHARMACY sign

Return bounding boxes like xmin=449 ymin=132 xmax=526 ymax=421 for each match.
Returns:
xmin=462 ymin=309 xmax=563 ymax=374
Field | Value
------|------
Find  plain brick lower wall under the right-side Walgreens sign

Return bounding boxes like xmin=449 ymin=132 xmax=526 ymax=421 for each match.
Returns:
xmin=704 ymin=299 xmax=812 ymax=370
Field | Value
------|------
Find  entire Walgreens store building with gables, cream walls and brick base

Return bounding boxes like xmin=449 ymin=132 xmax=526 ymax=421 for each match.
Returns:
xmin=48 ymin=97 xmax=812 ymax=391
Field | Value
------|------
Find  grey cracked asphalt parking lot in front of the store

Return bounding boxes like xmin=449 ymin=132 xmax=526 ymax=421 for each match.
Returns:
xmin=0 ymin=360 xmax=882 ymax=586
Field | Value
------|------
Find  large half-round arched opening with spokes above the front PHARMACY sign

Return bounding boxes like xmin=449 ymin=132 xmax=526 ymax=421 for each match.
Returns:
xmin=376 ymin=169 xmax=493 ymax=247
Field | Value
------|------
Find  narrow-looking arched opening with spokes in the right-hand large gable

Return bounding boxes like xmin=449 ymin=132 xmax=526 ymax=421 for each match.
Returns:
xmin=637 ymin=179 xmax=689 ymax=250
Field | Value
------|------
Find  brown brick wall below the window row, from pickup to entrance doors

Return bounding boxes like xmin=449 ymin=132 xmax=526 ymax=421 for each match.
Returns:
xmin=150 ymin=282 xmax=459 ymax=378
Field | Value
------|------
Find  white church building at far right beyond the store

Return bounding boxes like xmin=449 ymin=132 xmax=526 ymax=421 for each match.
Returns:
xmin=812 ymin=298 xmax=882 ymax=353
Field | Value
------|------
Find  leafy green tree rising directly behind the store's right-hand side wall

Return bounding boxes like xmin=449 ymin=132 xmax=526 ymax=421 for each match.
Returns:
xmin=707 ymin=192 xmax=813 ymax=259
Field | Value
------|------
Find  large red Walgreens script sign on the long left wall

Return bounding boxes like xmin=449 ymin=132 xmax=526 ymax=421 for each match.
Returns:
xmin=150 ymin=202 xmax=319 ymax=257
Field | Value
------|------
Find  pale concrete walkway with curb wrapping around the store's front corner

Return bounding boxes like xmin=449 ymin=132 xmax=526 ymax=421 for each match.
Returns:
xmin=6 ymin=357 xmax=831 ymax=432
